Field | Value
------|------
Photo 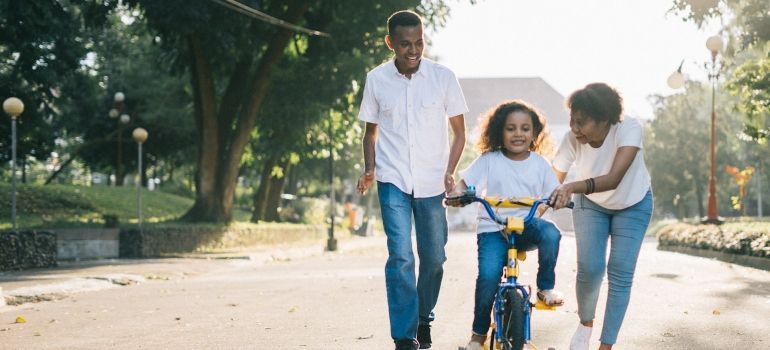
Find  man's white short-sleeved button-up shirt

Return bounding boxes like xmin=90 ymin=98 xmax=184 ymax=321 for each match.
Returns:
xmin=358 ymin=58 xmax=468 ymax=198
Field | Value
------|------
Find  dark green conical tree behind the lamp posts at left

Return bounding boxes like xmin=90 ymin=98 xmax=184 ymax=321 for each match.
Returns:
xmin=61 ymin=7 xmax=195 ymax=185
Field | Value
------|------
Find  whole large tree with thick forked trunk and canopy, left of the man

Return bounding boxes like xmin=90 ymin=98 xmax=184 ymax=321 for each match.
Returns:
xmin=129 ymin=0 xmax=443 ymax=221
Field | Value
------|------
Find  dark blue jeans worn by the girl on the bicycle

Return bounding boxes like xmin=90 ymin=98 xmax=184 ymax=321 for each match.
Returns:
xmin=473 ymin=218 xmax=561 ymax=335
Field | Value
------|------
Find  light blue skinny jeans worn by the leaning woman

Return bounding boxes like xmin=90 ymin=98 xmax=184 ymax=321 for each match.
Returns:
xmin=572 ymin=192 xmax=652 ymax=344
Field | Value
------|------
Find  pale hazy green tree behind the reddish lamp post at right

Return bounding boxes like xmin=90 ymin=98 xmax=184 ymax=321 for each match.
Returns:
xmin=644 ymin=82 xmax=751 ymax=218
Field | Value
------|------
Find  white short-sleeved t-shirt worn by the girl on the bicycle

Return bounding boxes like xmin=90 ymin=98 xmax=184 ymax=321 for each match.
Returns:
xmin=460 ymin=151 xmax=559 ymax=233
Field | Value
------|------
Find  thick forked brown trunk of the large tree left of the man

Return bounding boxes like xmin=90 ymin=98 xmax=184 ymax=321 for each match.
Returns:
xmin=184 ymin=2 xmax=308 ymax=222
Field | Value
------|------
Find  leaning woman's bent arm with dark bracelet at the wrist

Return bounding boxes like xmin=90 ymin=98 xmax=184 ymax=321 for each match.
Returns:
xmin=551 ymin=146 xmax=639 ymax=209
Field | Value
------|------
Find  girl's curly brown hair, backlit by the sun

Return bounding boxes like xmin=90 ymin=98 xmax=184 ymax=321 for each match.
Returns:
xmin=476 ymin=100 xmax=553 ymax=154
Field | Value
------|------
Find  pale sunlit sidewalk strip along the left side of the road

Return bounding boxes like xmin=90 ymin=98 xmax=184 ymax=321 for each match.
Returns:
xmin=0 ymin=235 xmax=385 ymax=313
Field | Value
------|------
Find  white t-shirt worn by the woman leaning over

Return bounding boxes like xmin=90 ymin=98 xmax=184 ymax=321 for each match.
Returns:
xmin=553 ymin=118 xmax=650 ymax=210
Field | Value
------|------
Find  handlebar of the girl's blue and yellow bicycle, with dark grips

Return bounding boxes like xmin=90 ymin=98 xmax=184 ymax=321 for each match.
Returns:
xmin=445 ymin=186 xmax=575 ymax=226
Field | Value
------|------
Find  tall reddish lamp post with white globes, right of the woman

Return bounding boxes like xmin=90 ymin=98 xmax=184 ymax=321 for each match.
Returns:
xmin=703 ymin=35 xmax=724 ymax=224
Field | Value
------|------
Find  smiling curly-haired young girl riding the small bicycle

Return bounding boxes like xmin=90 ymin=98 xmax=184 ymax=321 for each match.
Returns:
xmin=454 ymin=100 xmax=563 ymax=350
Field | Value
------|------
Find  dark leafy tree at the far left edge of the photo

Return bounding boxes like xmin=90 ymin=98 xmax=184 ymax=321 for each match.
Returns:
xmin=0 ymin=0 xmax=112 ymax=183
